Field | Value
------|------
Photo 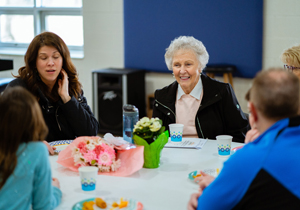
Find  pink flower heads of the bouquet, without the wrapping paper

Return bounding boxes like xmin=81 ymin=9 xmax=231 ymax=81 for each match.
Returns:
xmin=72 ymin=137 xmax=121 ymax=172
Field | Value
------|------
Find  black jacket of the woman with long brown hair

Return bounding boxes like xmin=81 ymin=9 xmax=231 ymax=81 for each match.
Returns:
xmin=7 ymin=79 xmax=99 ymax=142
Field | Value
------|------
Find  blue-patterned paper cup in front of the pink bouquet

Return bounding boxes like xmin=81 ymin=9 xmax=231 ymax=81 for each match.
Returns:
xmin=78 ymin=166 xmax=98 ymax=191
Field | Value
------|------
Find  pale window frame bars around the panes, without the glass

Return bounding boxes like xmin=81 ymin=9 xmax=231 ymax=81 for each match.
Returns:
xmin=0 ymin=4 xmax=84 ymax=58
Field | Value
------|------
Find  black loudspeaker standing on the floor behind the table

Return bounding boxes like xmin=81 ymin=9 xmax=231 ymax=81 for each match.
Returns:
xmin=92 ymin=68 xmax=146 ymax=136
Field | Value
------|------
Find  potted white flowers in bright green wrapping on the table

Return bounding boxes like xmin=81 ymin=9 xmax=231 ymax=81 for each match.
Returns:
xmin=133 ymin=117 xmax=169 ymax=168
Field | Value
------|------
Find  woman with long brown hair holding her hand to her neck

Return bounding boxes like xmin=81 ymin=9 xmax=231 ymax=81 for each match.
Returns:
xmin=7 ymin=32 xmax=99 ymax=142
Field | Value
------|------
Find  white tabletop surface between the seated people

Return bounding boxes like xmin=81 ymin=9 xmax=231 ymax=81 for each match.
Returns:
xmin=50 ymin=140 xmax=243 ymax=210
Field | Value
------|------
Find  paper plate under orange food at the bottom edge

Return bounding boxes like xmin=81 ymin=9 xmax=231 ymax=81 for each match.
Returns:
xmin=72 ymin=198 xmax=143 ymax=210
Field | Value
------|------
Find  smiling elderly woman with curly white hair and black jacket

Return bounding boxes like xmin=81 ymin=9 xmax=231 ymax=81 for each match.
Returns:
xmin=153 ymin=36 xmax=249 ymax=142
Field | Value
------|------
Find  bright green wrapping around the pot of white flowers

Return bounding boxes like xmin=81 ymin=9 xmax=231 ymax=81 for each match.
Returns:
xmin=133 ymin=131 xmax=169 ymax=168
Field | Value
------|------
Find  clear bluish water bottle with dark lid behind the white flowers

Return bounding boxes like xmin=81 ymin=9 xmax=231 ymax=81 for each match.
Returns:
xmin=123 ymin=104 xmax=139 ymax=143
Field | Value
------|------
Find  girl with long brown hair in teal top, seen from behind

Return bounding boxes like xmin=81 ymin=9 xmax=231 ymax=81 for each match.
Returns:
xmin=0 ymin=87 xmax=62 ymax=210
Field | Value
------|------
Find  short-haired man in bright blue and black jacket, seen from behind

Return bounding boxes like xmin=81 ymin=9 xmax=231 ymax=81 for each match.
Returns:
xmin=188 ymin=69 xmax=300 ymax=210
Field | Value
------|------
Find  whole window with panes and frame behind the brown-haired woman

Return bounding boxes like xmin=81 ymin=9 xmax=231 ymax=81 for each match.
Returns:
xmin=0 ymin=0 xmax=84 ymax=57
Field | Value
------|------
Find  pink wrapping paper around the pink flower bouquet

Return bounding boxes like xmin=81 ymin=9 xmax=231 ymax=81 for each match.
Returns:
xmin=56 ymin=135 xmax=144 ymax=176
